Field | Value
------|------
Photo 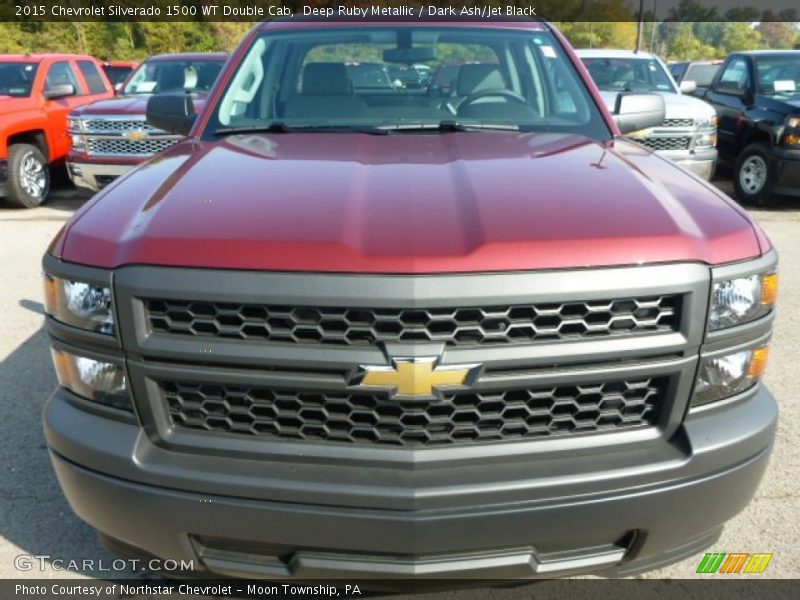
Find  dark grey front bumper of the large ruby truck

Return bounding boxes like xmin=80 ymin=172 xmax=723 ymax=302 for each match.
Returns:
xmin=44 ymin=386 xmax=777 ymax=579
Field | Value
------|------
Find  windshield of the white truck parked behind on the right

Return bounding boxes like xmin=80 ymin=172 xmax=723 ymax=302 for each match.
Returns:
xmin=581 ymin=57 xmax=677 ymax=92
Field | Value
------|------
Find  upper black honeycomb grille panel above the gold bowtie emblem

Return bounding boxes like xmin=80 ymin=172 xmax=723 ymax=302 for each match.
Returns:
xmin=145 ymin=295 xmax=681 ymax=346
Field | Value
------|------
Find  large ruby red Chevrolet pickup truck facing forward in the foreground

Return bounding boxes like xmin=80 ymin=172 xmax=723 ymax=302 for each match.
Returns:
xmin=44 ymin=20 xmax=777 ymax=579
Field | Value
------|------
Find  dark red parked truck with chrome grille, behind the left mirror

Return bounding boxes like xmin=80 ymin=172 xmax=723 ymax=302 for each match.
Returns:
xmin=67 ymin=52 xmax=227 ymax=192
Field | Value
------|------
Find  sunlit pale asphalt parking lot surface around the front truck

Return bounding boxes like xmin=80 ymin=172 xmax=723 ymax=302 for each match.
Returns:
xmin=0 ymin=180 xmax=800 ymax=598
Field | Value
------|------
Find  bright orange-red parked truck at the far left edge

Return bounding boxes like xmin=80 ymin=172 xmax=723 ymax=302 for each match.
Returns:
xmin=0 ymin=54 xmax=114 ymax=208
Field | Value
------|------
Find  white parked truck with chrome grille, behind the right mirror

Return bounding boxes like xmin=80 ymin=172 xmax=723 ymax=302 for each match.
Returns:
xmin=578 ymin=50 xmax=717 ymax=179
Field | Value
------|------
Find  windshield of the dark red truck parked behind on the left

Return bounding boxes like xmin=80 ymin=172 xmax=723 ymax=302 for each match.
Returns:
xmin=123 ymin=60 xmax=224 ymax=94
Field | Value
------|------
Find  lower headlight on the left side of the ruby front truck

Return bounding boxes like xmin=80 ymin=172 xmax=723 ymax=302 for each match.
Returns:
xmin=53 ymin=349 xmax=133 ymax=411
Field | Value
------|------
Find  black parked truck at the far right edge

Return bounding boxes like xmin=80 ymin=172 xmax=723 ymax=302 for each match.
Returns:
xmin=703 ymin=50 xmax=800 ymax=206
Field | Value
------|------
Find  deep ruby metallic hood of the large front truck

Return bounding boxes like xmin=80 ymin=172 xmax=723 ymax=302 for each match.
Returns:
xmin=57 ymin=132 xmax=761 ymax=273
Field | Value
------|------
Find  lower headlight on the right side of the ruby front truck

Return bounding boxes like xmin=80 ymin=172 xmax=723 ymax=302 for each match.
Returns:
xmin=692 ymin=346 xmax=769 ymax=406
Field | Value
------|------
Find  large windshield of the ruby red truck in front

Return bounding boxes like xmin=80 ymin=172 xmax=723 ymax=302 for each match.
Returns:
xmin=204 ymin=25 xmax=610 ymax=139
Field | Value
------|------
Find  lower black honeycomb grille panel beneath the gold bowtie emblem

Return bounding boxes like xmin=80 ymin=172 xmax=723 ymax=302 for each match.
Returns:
xmin=159 ymin=377 xmax=668 ymax=446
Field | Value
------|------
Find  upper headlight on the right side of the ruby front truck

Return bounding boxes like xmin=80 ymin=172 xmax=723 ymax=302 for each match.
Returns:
xmin=708 ymin=272 xmax=778 ymax=331
